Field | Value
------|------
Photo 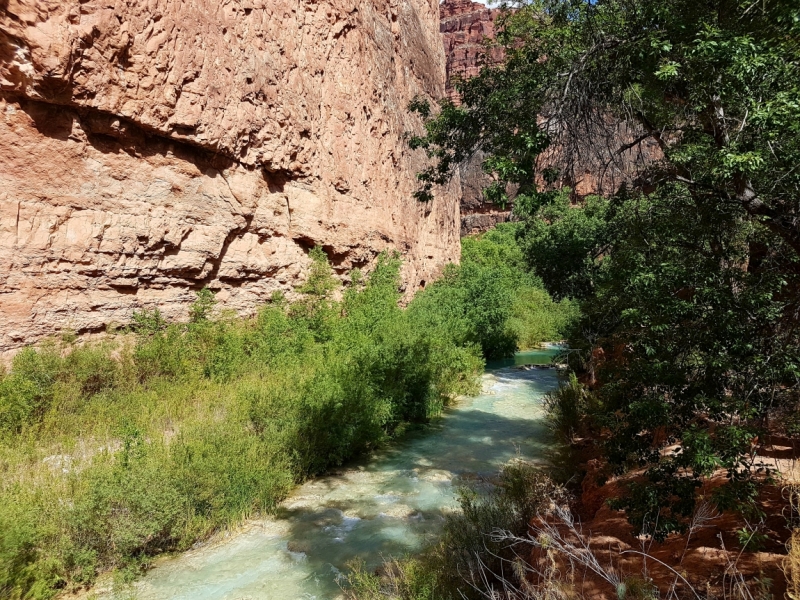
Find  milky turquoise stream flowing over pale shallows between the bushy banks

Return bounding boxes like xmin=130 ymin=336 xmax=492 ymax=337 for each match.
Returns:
xmin=112 ymin=348 xmax=557 ymax=600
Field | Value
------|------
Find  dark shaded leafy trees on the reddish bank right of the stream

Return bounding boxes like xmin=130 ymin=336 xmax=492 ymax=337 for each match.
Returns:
xmin=396 ymin=0 xmax=800 ymax=596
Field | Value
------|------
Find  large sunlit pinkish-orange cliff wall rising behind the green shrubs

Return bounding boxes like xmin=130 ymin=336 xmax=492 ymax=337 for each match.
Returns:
xmin=0 ymin=0 xmax=460 ymax=351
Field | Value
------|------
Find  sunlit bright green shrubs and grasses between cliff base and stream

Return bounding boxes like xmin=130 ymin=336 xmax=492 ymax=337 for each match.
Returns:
xmin=0 ymin=232 xmax=573 ymax=599
